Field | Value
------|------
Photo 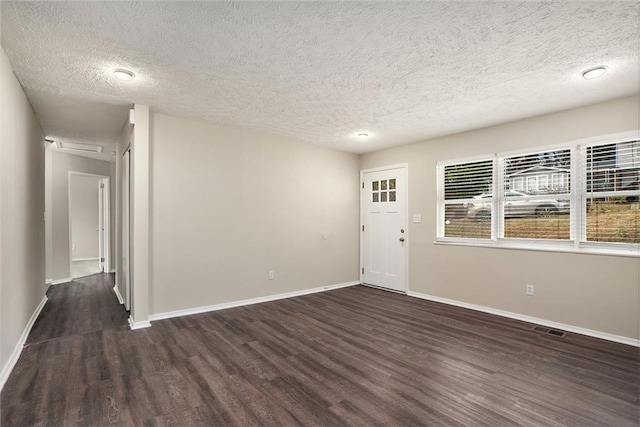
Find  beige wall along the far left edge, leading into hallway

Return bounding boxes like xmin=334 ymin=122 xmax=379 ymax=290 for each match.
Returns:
xmin=0 ymin=49 xmax=46 ymax=378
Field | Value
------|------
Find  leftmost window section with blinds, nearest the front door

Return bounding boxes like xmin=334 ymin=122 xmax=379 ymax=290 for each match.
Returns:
xmin=439 ymin=160 xmax=494 ymax=239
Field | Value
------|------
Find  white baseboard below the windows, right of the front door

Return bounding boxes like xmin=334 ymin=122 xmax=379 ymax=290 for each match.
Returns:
xmin=407 ymin=291 xmax=640 ymax=347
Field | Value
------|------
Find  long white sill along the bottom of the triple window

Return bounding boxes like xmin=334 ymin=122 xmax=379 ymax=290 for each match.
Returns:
xmin=433 ymin=238 xmax=640 ymax=258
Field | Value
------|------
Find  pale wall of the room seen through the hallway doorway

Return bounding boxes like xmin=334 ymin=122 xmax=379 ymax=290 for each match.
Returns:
xmin=70 ymin=175 xmax=100 ymax=260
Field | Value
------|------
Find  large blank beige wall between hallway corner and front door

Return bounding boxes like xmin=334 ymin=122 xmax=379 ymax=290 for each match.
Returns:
xmin=150 ymin=114 xmax=359 ymax=313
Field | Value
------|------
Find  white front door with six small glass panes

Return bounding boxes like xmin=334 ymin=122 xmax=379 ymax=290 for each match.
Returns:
xmin=360 ymin=165 xmax=409 ymax=292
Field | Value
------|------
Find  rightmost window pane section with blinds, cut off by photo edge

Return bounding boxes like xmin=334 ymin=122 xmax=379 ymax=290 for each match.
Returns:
xmin=583 ymin=140 xmax=640 ymax=243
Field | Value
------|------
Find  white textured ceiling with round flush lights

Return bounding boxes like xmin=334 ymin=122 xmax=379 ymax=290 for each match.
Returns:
xmin=1 ymin=1 xmax=640 ymax=159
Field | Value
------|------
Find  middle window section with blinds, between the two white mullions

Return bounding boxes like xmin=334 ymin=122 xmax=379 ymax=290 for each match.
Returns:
xmin=500 ymin=149 xmax=571 ymax=240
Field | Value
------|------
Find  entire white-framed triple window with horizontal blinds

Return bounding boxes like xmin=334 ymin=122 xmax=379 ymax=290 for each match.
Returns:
xmin=437 ymin=132 xmax=640 ymax=256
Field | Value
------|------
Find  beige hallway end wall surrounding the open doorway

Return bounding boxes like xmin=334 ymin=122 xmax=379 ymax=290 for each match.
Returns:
xmin=51 ymin=152 xmax=115 ymax=280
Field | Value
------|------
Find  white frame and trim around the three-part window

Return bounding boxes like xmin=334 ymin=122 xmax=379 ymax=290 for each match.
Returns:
xmin=434 ymin=130 xmax=640 ymax=257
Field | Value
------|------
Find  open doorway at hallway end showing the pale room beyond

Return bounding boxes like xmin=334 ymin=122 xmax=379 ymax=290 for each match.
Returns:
xmin=68 ymin=172 xmax=111 ymax=279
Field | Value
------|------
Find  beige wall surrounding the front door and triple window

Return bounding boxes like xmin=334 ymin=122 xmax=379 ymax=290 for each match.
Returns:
xmin=360 ymin=97 xmax=640 ymax=339
